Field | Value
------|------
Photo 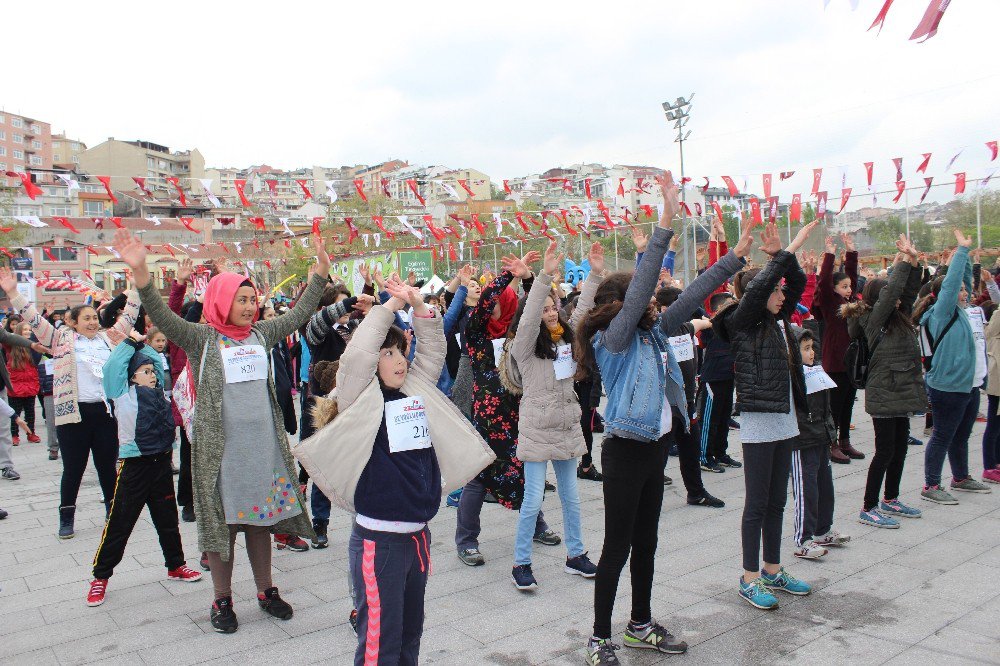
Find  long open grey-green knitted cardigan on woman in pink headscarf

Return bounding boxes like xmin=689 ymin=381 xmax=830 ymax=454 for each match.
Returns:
xmin=139 ymin=275 xmax=327 ymax=560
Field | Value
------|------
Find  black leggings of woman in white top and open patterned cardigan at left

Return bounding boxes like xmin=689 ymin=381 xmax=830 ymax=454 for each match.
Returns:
xmin=56 ymin=402 xmax=118 ymax=506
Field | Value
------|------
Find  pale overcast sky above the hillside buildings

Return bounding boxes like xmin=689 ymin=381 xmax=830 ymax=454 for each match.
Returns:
xmin=7 ymin=0 xmax=1000 ymax=198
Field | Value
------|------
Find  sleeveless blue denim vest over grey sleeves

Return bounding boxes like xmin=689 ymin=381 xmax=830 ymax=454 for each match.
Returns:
xmin=593 ymin=322 xmax=691 ymax=442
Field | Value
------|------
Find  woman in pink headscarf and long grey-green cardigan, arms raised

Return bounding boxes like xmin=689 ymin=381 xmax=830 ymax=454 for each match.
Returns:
xmin=115 ymin=230 xmax=330 ymax=633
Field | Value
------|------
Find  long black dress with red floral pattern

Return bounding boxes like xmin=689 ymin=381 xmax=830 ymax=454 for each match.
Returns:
xmin=465 ymin=271 xmax=530 ymax=511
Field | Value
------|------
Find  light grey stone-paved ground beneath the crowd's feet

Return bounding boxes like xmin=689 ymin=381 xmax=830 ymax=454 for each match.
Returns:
xmin=0 ymin=396 xmax=1000 ymax=666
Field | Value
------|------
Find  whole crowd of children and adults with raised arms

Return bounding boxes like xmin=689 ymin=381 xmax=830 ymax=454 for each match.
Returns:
xmin=0 ymin=172 xmax=1000 ymax=666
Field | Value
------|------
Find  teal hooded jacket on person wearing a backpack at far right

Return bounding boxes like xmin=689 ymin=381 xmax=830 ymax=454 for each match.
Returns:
xmin=920 ymin=246 xmax=976 ymax=393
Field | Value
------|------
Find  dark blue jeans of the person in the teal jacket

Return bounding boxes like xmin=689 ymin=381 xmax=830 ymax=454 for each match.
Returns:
xmin=924 ymin=386 xmax=979 ymax=486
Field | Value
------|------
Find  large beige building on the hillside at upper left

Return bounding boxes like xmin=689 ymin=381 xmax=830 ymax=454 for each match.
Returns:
xmin=79 ymin=137 xmax=205 ymax=191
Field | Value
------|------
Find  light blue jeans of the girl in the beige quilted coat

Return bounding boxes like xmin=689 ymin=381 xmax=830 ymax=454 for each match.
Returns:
xmin=514 ymin=458 xmax=583 ymax=566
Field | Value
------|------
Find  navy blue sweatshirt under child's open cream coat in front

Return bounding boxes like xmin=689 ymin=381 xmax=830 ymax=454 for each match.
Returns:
xmin=354 ymin=386 xmax=441 ymax=523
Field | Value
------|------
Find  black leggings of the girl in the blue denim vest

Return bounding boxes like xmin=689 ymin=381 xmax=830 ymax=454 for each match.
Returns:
xmin=594 ymin=437 xmax=667 ymax=638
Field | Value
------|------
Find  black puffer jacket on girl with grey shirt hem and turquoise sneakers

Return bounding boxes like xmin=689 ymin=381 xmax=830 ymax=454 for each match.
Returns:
xmin=712 ymin=250 xmax=806 ymax=414
